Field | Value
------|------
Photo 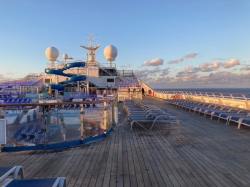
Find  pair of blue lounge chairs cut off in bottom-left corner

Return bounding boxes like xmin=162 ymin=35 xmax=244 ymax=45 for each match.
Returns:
xmin=0 ymin=166 xmax=66 ymax=187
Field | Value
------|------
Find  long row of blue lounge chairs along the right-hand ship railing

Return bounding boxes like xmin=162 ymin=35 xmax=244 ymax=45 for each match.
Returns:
xmin=165 ymin=99 xmax=250 ymax=129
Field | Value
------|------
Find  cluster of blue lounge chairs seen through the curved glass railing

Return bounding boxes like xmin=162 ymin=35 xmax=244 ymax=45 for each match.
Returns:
xmin=11 ymin=124 xmax=56 ymax=143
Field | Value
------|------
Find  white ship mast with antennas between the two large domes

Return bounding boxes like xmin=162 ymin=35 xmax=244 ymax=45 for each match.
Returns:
xmin=80 ymin=31 xmax=100 ymax=65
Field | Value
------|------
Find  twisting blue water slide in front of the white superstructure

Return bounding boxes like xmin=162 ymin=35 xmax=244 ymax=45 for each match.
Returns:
xmin=45 ymin=62 xmax=87 ymax=90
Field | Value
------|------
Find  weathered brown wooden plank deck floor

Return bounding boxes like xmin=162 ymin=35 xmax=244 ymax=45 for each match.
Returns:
xmin=0 ymin=97 xmax=250 ymax=187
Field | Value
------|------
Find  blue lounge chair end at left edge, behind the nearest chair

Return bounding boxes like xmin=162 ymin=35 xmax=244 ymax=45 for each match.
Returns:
xmin=0 ymin=166 xmax=24 ymax=182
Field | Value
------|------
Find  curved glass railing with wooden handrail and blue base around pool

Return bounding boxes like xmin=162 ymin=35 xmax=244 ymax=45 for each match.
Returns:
xmin=0 ymin=93 xmax=118 ymax=151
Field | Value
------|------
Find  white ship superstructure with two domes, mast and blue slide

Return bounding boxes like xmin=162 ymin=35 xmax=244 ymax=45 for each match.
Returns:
xmin=43 ymin=33 xmax=140 ymax=98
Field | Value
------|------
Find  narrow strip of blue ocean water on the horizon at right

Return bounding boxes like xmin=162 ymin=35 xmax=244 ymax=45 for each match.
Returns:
xmin=154 ymin=88 xmax=250 ymax=94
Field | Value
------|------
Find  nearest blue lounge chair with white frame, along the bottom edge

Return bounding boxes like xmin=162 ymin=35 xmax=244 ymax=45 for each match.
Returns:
xmin=3 ymin=177 xmax=66 ymax=187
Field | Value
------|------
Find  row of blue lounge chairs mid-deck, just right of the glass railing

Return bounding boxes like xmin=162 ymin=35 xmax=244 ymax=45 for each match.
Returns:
xmin=123 ymin=98 xmax=186 ymax=131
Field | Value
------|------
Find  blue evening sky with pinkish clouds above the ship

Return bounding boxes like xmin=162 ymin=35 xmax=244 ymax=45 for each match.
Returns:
xmin=0 ymin=0 xmax=250 ymax=88
